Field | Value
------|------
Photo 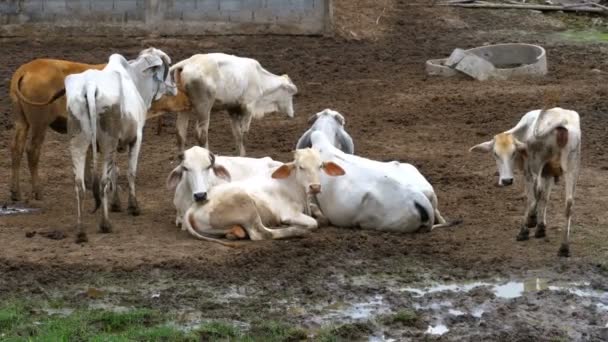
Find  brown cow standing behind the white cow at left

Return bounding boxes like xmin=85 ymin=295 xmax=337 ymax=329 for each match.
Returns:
xmin=10 ymin=58 xmax=185 ymax=201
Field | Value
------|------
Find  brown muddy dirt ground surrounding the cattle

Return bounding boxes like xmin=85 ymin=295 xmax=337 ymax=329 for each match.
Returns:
xmin=0 ymin=0 xmax=608 ymax=341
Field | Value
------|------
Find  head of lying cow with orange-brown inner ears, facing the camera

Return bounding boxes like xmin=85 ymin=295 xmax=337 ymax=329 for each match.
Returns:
xmin=272 ymin=148 xmax=344 ymax=195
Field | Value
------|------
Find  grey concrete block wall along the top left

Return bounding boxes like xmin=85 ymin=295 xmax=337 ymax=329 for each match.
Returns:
xmin=0 ymin=0 xmax=332 ymax=36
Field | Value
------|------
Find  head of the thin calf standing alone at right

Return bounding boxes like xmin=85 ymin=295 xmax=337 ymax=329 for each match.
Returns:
xmin=469 ymin=133 xmax=527 ymax=186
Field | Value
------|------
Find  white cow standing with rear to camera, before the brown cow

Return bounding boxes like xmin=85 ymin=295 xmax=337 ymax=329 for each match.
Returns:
xmin=65 ymin=48 xmax=177 ymax=242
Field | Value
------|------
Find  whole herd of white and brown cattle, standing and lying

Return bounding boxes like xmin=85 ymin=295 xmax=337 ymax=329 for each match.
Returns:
xmin=10 ymin=48 xmax=581 ymax=256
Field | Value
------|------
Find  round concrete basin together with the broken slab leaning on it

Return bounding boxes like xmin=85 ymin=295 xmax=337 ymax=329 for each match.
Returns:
xmin=426 ymin=43 xmax=547 ymax=81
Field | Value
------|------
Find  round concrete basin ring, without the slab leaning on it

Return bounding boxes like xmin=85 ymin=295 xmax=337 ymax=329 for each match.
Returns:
xmin=426 ymin=43 xmax=547 ymax=80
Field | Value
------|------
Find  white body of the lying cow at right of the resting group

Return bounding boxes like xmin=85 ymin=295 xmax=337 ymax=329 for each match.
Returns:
xmin=310 ymin=131 xmax=452 ymax=233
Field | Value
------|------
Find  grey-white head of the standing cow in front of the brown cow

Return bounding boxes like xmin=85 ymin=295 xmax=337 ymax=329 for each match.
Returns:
xmin=137 ymin=47 xmax=177 ymax=100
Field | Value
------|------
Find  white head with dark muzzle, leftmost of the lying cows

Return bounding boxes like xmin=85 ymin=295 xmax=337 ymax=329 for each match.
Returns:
xmin=167 ymin=146 xmax=230 ymax=202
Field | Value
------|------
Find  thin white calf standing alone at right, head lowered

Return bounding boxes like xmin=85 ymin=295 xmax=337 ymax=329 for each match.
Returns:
xmin=470 ymin=107 xmax=581 ymax=257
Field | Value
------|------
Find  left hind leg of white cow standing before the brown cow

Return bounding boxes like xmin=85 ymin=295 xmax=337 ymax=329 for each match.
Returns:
xmin=70 ymin=131 xmax=89 ymax=243
